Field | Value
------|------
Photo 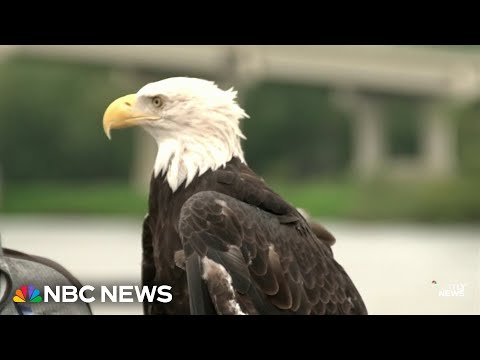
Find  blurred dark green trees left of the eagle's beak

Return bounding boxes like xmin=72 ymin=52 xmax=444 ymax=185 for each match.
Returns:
xmin=0 ymin=58 xmax=137 ymax=180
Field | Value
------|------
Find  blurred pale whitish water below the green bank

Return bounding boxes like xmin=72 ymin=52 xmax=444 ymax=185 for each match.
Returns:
xmin=0 ymin=215 xmax=480 ymax=314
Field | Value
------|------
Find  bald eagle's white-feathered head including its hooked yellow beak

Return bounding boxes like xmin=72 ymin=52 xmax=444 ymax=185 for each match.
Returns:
xmin=103 ymin=77 xmax=248 ymax=191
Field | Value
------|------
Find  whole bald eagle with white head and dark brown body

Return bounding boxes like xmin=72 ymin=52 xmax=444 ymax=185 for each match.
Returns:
xmin=103 ymin=77 xmax=367 ymax=315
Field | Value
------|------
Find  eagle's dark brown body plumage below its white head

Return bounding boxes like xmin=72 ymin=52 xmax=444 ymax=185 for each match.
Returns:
xmin=142 ymin=158 xmax=367 ymax=314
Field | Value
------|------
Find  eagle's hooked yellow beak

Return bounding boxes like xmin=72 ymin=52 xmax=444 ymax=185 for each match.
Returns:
xmin=103 ymin=94 xmax=149 ymax=139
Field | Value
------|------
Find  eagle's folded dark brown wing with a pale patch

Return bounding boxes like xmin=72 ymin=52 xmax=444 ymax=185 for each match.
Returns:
xmin=179 ymin=189 xmax=367 ymax=314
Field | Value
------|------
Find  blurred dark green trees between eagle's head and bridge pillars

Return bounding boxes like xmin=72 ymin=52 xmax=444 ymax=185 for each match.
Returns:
xmin=243 ymin=83 xmax=350 ymax=179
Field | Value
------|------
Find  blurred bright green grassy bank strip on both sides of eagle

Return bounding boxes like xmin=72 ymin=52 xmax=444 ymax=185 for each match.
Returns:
xmin=3 ymin=179 xmax=480 ymax=223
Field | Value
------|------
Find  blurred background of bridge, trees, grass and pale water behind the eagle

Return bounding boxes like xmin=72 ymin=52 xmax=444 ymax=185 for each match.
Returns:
xmin=0 ymin=45 xmax=480 ymax=314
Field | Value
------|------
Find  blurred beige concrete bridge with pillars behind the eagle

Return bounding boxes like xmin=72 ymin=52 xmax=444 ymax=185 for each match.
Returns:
xmin=0 ymin=45 xmax=480 ymax=188
